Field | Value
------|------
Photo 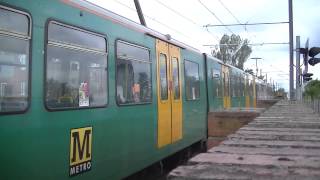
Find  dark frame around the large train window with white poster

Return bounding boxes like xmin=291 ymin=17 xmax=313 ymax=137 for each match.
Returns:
xmin=43 ymin=18 xmax=110 ymax=112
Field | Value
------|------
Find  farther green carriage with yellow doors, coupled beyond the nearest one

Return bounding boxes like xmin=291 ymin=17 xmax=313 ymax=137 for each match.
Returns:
xmin=205 ymin=56 xmax=260 ymax=112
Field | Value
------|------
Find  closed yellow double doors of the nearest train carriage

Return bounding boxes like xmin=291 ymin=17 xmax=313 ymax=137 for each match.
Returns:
xmin=156 ymin=40 xmax=182 ymax=148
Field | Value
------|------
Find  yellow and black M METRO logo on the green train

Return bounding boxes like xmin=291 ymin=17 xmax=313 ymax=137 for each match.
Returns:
xmin=69 ymin=127 xmax=92 ymax=176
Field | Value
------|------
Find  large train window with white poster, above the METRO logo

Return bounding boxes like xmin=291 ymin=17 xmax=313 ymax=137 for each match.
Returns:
xmin=45 ymin=21 xmax=107 ymax=110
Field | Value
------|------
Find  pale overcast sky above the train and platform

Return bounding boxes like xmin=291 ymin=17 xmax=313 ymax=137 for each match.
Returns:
xmin=89 ymin=0 xmax=320 ymax=89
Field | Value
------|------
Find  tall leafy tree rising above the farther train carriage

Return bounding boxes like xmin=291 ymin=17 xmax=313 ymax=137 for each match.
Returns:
xmin=211 ymin=34 xmax=252 ymax=70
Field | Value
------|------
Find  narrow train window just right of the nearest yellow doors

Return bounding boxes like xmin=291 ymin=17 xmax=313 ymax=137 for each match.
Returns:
xmin=184 ymin=60 xmax=200 ymax=100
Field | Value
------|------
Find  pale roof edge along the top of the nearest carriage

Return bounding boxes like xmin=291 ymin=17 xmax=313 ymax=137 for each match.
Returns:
xmin=61 ymin=0 xmax=200 ymax=53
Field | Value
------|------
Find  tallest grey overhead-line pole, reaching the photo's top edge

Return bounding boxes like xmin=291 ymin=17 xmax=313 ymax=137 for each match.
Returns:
xmin=288 ymin=0 xmax=294 ymax=100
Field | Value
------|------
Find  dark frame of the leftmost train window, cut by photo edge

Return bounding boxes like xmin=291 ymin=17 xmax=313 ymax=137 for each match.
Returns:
xmin=0 ymin=2 xmax=33 ymax=116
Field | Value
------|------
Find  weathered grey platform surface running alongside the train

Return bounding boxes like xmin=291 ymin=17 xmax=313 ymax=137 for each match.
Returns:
xmin=167 ymin=101 xmax=320 ymax=180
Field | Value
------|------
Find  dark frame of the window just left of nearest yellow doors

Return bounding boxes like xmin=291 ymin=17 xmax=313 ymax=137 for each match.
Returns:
xmin=114 ymin=38 xmax=153 ymax=107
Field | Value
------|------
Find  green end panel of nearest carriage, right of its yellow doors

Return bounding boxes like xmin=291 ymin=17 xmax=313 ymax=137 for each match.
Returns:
xmin=181 ymin=50 xmax=207 ymax=143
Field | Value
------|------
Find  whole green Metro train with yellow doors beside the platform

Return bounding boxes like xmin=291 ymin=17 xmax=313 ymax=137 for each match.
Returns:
xmin=0 ymin=0 xmax=272 ymax=179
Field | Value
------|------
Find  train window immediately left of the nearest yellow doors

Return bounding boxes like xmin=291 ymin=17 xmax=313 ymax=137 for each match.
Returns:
xmin=116 ymin=40 xmax=151 ymax=105
